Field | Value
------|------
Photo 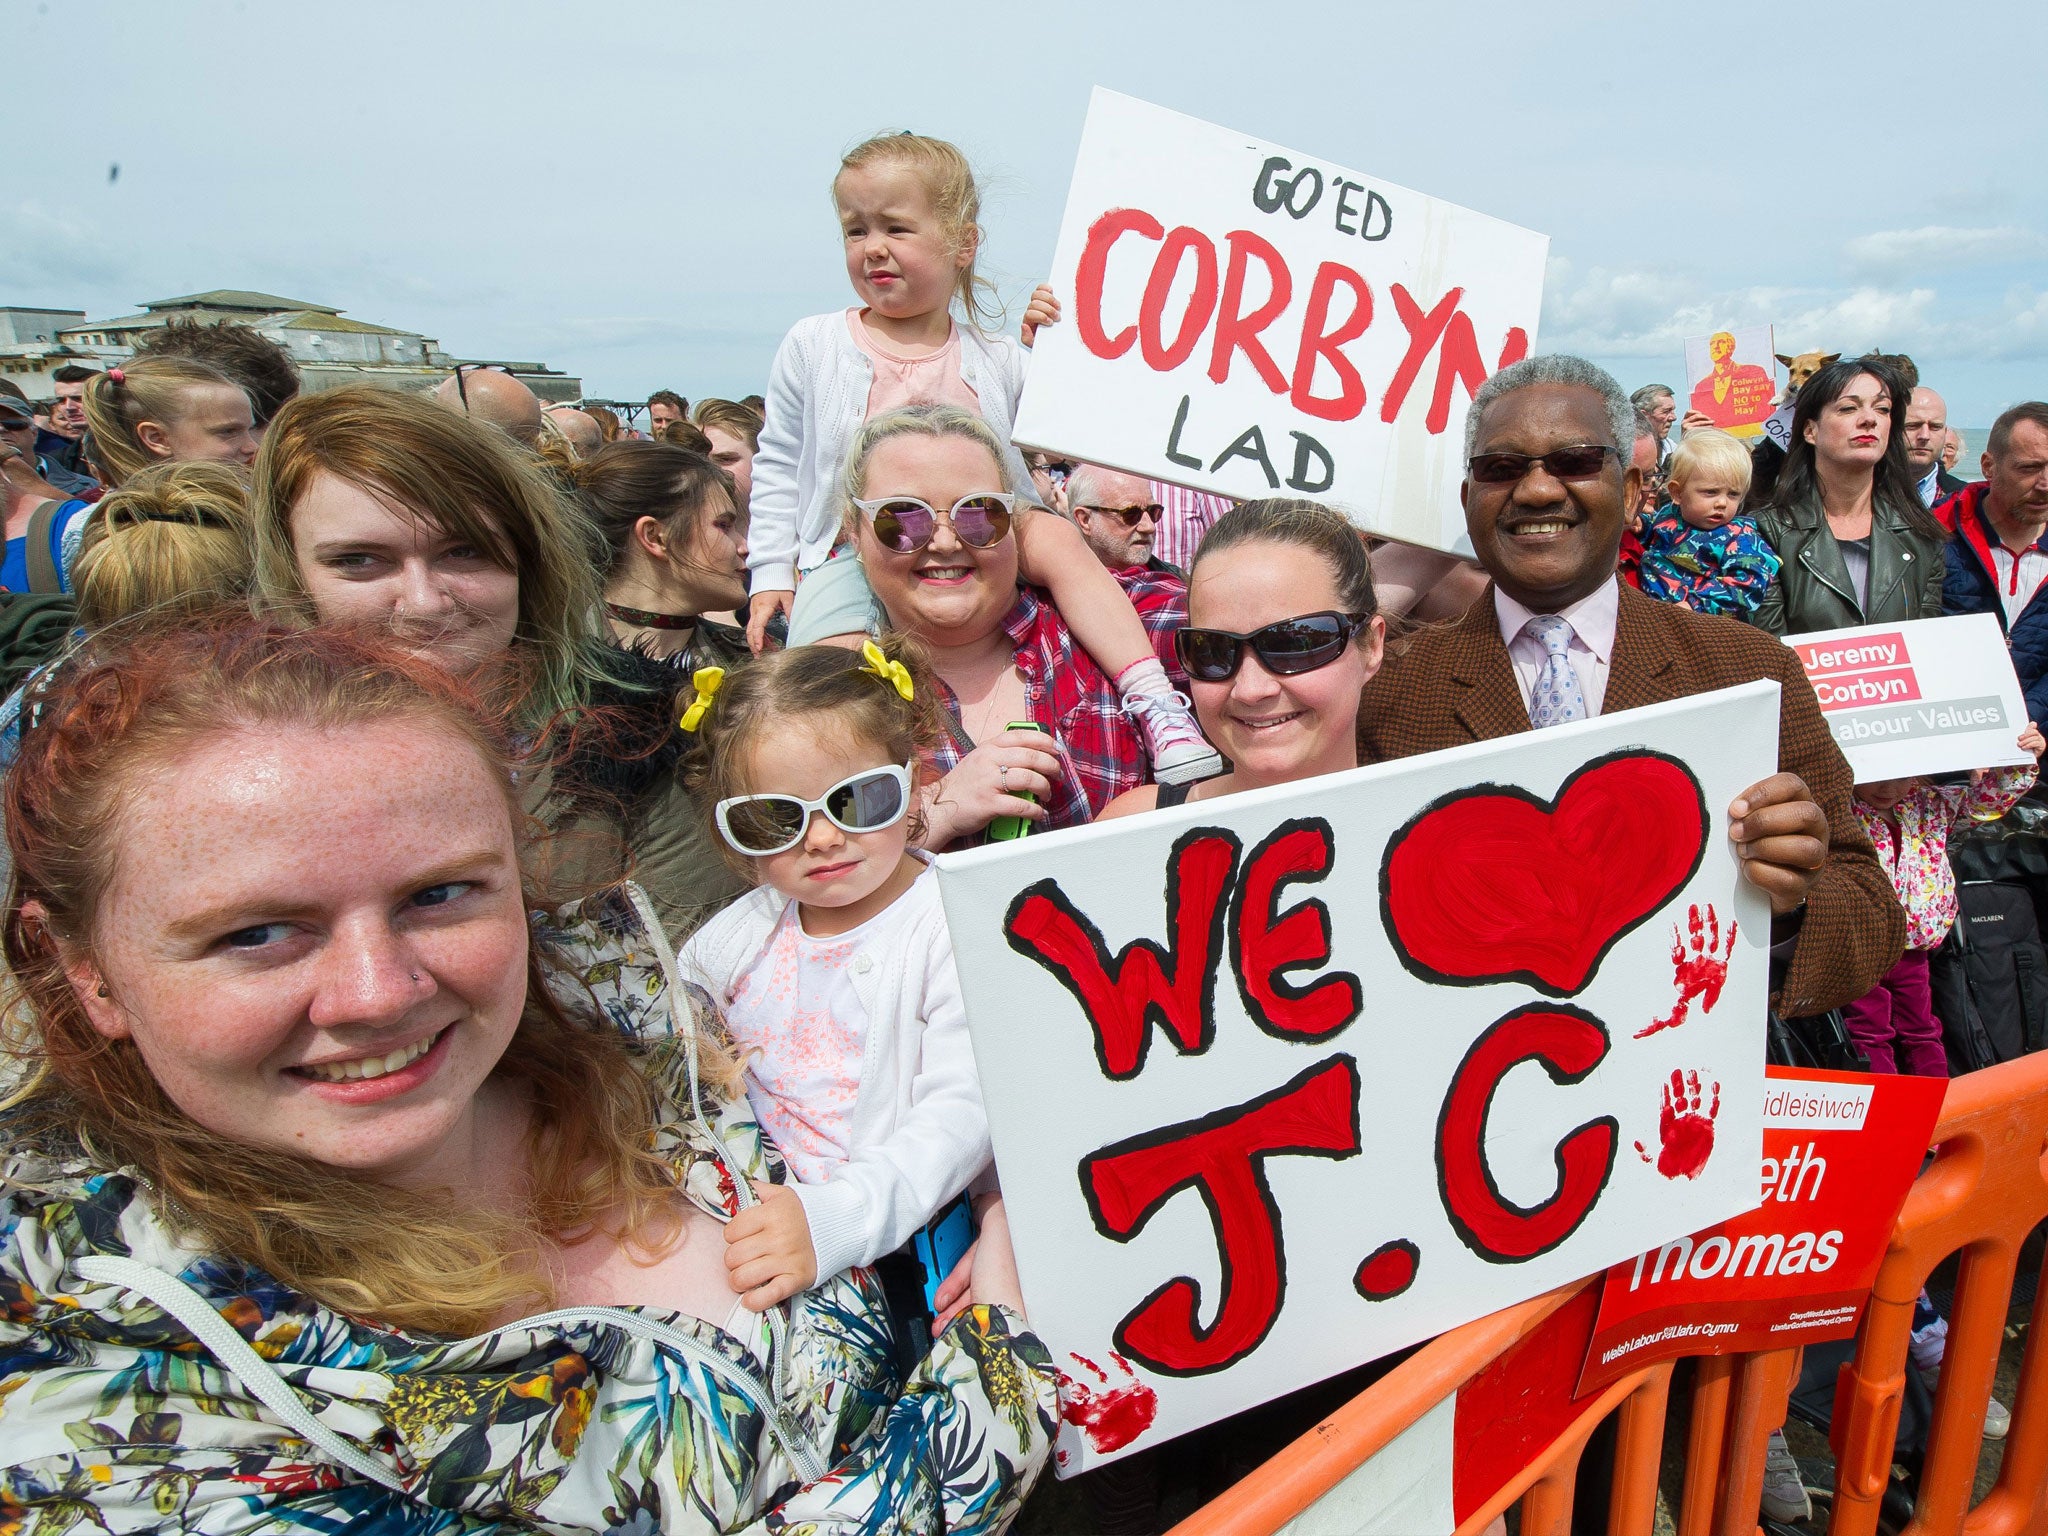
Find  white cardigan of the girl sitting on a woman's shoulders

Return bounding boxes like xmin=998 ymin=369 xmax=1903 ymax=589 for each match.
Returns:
xmin=748 ymin=309 xmax=1036 ymax=592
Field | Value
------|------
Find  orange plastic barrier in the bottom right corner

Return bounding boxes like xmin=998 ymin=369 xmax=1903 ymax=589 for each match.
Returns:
xmin=1171 ymin=1053 xmax=2048 ymax=1536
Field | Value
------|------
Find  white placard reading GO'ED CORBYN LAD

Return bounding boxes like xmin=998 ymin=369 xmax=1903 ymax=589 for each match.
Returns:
xmin=1016 ymin=88 xmax=1550 ymax=555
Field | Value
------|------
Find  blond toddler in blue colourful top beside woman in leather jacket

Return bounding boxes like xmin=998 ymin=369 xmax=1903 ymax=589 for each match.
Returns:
xmin=1636 ymin=428 xmax=1778 ymax=618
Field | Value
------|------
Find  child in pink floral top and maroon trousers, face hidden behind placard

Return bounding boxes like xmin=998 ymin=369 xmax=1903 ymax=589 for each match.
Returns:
xmin=1843 ymin=721 xmax=2048 ymax=1077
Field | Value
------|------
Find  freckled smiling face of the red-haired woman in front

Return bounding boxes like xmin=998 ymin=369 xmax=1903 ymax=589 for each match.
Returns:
xmin=72 ymin=719 xmax=526 ymax=1178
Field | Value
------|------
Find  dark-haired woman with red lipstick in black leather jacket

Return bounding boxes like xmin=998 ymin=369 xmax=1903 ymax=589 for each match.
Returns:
xmin=1751 ymin=356 xmax=1946 ymax=635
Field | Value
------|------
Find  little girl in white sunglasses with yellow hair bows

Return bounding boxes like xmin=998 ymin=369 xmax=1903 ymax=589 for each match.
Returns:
xmin=682 ymin=637 xmax=989 ymax=1358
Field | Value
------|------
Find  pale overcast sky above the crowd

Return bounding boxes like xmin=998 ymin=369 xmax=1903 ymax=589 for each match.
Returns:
xmin=0 ymin=0 xmax=2048 ymax=426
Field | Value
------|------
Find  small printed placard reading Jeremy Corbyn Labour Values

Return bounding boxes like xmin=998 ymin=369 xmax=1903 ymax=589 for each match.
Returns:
xmin=1786 ymin=612 xmax=2034 ymax=784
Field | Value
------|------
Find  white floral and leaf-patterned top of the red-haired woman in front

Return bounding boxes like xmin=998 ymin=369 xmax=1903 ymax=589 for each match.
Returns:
xmin=0 ymin=893 xmax=1059 ymax=1536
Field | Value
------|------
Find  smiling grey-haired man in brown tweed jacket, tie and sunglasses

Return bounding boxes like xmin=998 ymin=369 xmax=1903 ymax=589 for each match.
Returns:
xmin=1358 ymin=356 xmax=1905 ymax=1016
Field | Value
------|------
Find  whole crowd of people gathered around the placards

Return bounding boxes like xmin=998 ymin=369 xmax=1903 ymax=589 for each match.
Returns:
xmin=0 ymin=123 xmax=2048 ymax=1532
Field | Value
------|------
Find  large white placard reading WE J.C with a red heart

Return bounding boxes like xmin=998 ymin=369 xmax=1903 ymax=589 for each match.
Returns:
xmin=938 ymin=682 xmax=1778 ymax=1475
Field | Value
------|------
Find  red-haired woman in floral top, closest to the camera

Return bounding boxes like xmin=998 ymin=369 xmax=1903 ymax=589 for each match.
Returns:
xmin=0 ymin=616 xmax=1059 ymax=1536
